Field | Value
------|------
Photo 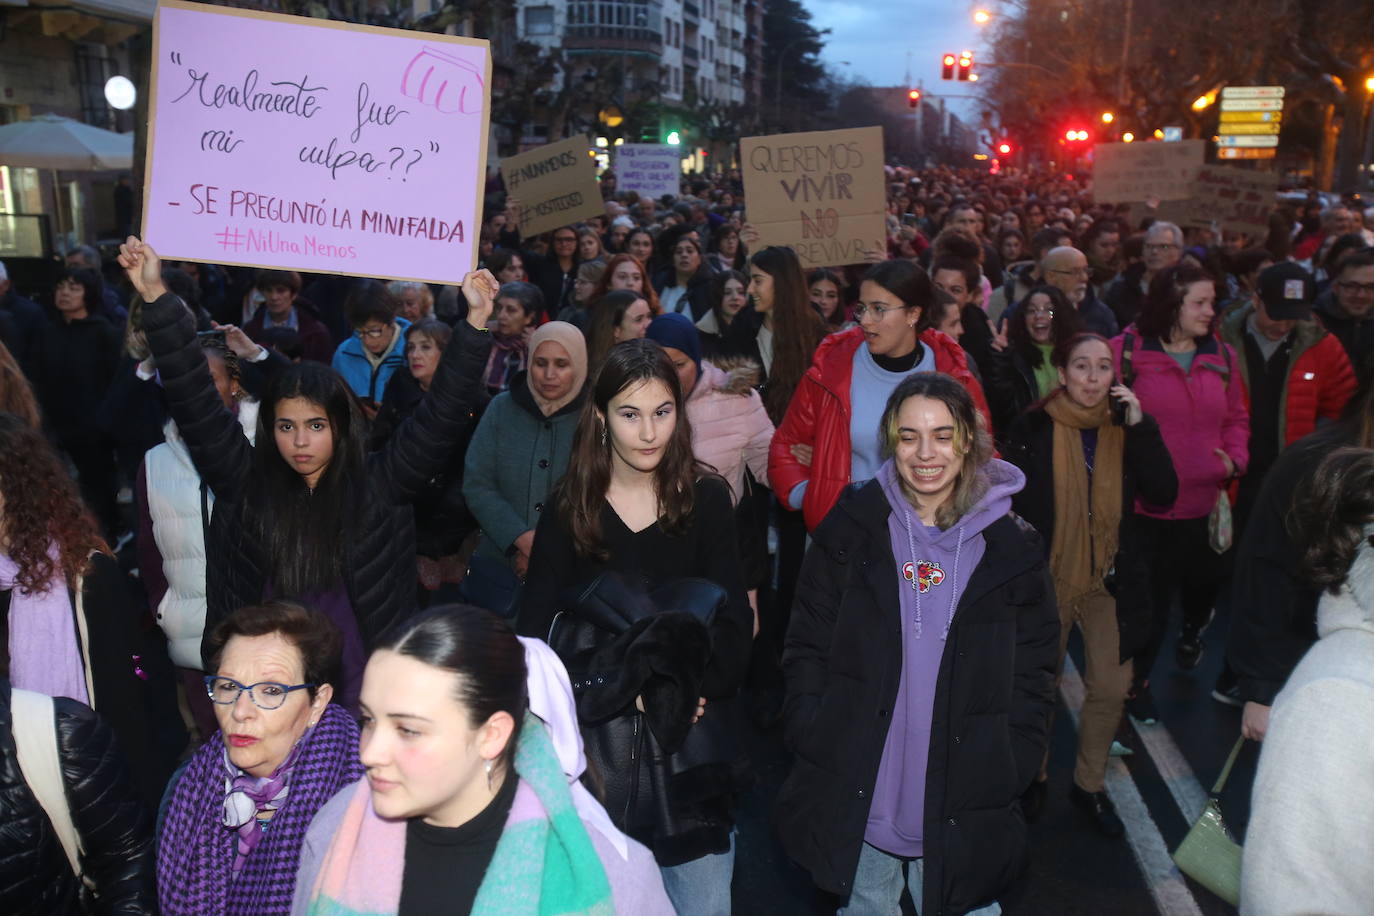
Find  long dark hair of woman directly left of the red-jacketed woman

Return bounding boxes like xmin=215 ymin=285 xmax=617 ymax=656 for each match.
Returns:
xmin=749 ymin=244 xmax=826 ymax=423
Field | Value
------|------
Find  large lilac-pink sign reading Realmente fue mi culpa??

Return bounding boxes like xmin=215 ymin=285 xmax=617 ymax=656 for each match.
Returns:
xmin=143 ymin=0 xmax=492 ymax=283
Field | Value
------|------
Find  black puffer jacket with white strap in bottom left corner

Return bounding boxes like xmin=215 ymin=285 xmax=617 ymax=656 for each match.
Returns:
xmin=0 ymin=681 xmax=157 ymax=916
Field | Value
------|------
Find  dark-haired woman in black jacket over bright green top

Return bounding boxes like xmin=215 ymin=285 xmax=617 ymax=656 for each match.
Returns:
xmin=988 ymin=286 xmax=1083 ymax=442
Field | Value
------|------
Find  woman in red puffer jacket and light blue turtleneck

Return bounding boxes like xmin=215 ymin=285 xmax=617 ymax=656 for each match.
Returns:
xmin=768 ymin=260 xmax=988 ymax=531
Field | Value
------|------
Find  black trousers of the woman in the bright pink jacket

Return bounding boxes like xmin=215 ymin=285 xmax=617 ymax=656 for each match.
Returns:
xmin=1135 ymin=515 xmax=1234 ymax=689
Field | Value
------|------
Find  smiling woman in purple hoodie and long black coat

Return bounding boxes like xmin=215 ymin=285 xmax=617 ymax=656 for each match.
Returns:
xmin=778 ymin=374 xmax=1059 ymax=913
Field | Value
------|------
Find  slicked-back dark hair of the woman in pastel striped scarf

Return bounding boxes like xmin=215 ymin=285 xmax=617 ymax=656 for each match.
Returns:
xmin=376 ymin=604 xmax=529 ymax=773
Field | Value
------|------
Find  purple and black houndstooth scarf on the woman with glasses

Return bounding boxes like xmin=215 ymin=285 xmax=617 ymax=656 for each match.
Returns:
xmin=158 ymin=703 xmax=364 ymax=916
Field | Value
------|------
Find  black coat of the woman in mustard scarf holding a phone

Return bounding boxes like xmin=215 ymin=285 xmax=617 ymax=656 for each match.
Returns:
xmin=1002 ymin=408 xmax=1179 ymax=662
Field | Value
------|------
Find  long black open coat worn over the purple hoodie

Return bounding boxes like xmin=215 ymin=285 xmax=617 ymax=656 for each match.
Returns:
xmin=776 ymin=481 xmax=1059 ymax=916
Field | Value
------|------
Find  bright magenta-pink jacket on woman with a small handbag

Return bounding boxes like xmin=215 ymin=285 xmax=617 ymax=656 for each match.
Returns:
xmin=1112 ymin=325 xmax=1250 ymax=519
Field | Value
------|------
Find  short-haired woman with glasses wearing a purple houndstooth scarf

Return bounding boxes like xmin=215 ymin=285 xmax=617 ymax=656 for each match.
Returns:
xmin=158 ymin=600 xmax=363 ymax=916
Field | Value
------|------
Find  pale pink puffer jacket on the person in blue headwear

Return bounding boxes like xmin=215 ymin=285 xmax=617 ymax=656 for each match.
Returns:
xmin=687 ymin=360 xmax=774 ymax=503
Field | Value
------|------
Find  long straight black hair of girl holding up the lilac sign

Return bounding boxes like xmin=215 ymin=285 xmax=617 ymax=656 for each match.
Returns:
xmin=247 ymin=363 xmax=368 ymax=597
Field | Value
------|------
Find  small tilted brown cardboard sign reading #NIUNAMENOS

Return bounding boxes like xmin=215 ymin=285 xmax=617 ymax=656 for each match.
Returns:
xmin=502 ymin=136 xmax=605 ymax=238
